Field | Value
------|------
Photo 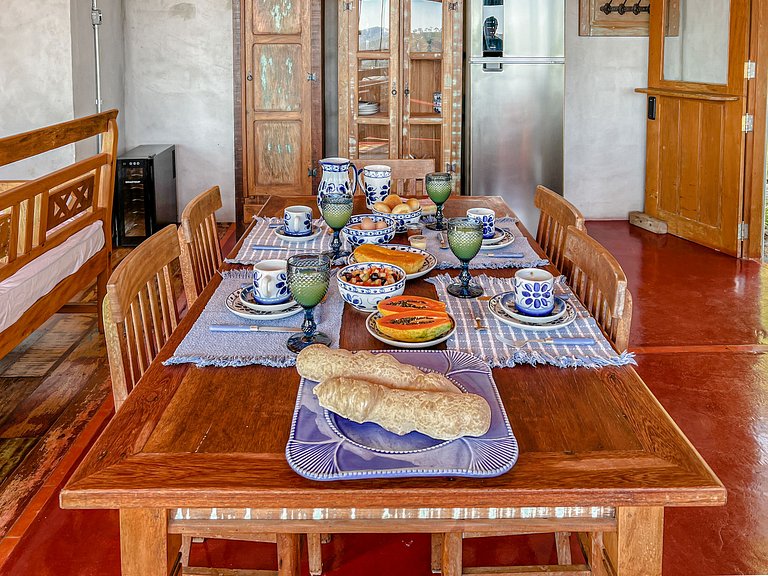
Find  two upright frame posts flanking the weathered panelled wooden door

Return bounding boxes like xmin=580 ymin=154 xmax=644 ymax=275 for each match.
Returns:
xmin=232 ymin=0 xmax=325 ymax=236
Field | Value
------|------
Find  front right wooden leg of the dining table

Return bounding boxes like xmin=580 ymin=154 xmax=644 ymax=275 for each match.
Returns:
xmin=603 ymin=506 xmax=664 ymax=576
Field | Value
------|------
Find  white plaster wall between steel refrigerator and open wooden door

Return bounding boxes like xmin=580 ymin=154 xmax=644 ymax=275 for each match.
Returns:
xmin=564 ymin=0 xmax=648 ymax=219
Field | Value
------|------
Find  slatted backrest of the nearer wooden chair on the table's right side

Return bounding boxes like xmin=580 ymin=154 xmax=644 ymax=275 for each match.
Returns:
xmin=565 ymin=226 xmax=632 ymax=352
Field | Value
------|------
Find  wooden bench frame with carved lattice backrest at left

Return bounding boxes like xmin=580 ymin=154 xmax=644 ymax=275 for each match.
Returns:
xmin=0 ymin=110 xmax=117 ymax=358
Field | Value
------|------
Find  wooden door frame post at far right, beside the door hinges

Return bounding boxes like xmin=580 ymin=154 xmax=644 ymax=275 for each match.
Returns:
xmin=741 ymin=0 xmax=768 ymax=260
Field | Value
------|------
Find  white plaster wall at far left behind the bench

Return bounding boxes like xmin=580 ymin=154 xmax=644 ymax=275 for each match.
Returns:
xmin=0 ymin=0 xmax=74 ymax=180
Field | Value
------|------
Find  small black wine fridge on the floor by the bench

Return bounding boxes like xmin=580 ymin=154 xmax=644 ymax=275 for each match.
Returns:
xmin=112 ymin=144 xmax=177 ymax=246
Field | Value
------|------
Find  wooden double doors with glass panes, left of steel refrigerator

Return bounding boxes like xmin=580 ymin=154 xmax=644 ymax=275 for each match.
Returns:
xmin=339 ymin=0 xmax=462 ymax=177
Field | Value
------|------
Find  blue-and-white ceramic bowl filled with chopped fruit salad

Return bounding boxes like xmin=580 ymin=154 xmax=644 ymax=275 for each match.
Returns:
xmin=336 ymin=262 xmax=405 ymax=312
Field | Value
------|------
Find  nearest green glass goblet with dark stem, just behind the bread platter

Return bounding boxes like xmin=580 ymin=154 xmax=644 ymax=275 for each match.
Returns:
xmin=287 ymin=254 xmax=331 ymax=353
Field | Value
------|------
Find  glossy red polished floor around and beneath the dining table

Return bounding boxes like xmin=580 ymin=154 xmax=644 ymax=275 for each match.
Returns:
xmin=0 ymin=222 xmax=768 ymax=576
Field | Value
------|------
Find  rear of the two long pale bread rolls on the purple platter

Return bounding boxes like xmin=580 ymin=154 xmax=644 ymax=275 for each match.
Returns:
xmin=296 ymin=344 xmax=460 ymax=392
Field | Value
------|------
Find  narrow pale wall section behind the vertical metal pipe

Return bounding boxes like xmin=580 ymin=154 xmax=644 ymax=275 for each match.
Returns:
xmin=70 ymin=0 xmax=125 ymax=159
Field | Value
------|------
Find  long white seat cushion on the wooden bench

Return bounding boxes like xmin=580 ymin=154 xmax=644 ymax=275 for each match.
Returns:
xmin=0 ymin=220 xmax=104 ymax=331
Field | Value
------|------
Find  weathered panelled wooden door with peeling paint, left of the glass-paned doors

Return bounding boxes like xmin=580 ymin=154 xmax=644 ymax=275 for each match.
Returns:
xmin=243 ymin=0 xmax=319 ymax=201
